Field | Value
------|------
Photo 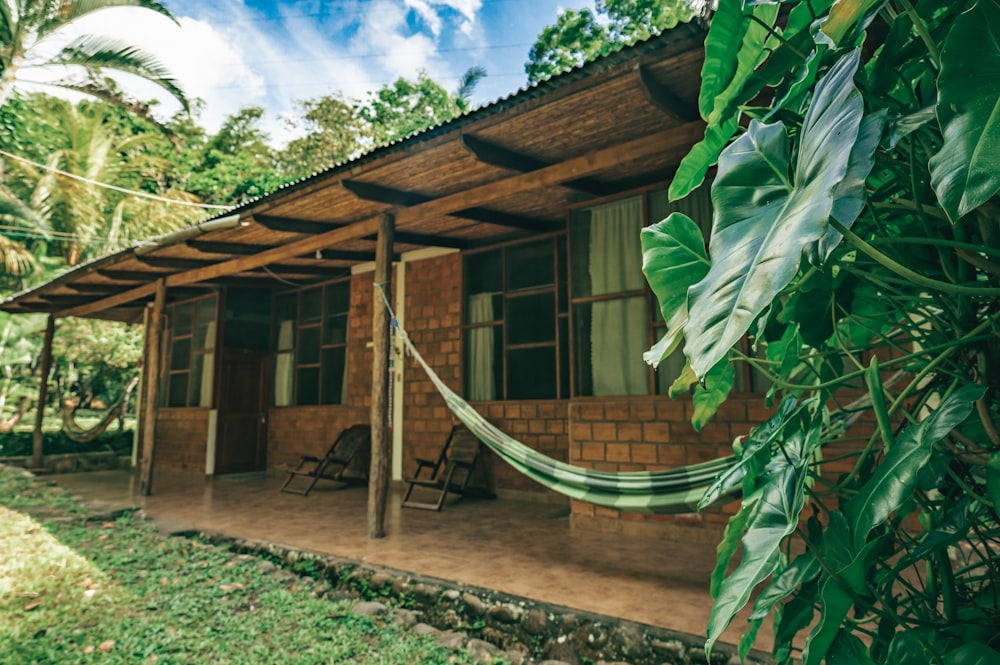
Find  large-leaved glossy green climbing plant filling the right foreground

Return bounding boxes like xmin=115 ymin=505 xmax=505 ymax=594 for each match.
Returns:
xmin=642 ymin=0 xmax=1000 ymax=665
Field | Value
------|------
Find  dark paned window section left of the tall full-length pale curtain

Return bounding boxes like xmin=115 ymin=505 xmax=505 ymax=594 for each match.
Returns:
xmin=464 ymin=236 xmax=569 ymax=400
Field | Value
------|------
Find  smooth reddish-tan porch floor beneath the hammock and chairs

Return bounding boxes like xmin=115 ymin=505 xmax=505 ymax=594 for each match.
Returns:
xmin=50 ymin=471 xmax=773 ymax=650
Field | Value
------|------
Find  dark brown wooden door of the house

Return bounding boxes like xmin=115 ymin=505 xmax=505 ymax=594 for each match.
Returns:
xmin=215 ymin=350 xmax=268 ymax=475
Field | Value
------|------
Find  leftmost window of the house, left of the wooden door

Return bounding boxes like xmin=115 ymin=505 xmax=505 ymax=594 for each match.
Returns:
xmin=160 ymin=295 xmax=217 ymax=406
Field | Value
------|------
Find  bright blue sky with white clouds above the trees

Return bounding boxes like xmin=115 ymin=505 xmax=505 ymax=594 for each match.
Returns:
xmin=62 ymin=0 xmax=593 ymax=145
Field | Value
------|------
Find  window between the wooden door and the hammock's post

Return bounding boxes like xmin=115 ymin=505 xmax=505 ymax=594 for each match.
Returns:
xmin=274 ymin=281 xmax=351 ymax=406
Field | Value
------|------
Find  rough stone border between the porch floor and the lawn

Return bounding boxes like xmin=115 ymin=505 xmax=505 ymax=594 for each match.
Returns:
xmin=195 ymin=531 xmax=772 ymax=665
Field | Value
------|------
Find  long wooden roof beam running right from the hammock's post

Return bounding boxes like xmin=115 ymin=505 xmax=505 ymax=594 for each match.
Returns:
xmin=396 ymin=122 xmax=705 ymax=226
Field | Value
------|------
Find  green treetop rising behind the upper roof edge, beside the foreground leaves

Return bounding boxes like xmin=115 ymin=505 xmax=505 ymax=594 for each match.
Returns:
xmin=524 ymin=0 xmax=695 ymax=83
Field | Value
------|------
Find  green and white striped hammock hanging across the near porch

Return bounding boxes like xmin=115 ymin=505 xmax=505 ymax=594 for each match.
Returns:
xmin=375 ymin=284 xmax=739 ymax=514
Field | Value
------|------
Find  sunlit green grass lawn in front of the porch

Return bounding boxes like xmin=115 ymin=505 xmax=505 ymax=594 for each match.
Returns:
xmin=0 ymin=466 xmax=486 ymax=665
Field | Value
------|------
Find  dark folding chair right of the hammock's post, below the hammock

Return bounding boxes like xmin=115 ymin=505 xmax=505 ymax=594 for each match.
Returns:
xmin=403 ymin=425 xmax=495 ymax=511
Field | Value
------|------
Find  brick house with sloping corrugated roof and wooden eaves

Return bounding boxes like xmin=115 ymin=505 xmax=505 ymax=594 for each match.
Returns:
xmin=0 ymin=26 xmax=768 ymax=537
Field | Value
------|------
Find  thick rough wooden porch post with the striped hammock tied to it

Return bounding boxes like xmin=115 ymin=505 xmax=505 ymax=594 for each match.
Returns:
xmin=368 ymin=213 xmax=396 ymax=538
